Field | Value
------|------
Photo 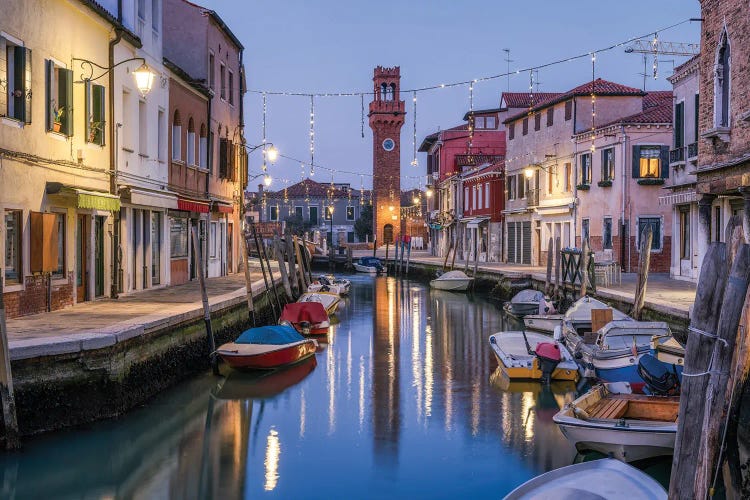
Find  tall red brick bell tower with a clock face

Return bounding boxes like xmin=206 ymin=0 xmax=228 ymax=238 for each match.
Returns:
xmin=368 ymin=66 xmax=406 ymax=245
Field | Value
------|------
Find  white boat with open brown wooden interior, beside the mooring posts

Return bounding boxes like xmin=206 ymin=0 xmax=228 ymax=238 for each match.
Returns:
xmin=554 ymin=384 xmax=680 ymax=462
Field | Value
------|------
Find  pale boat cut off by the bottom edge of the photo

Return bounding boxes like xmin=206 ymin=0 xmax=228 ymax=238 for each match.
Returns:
xmin=505 ymin=458 xmax=667 ymax=500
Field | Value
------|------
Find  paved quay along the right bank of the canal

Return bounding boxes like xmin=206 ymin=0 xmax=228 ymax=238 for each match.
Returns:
xmin=353 ymin=249 xmax=696 ymax=319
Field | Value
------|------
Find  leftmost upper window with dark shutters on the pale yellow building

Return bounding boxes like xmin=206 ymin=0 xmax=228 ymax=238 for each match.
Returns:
xmin=0 ymin=36 xmax=31 ymax=123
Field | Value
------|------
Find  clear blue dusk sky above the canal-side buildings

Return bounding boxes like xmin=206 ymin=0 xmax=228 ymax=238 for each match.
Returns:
xmin=198 ymin=0 xmax=700 ymax=190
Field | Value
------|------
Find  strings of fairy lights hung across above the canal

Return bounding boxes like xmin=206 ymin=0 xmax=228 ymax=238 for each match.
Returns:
xmin=247 ymin=19 xmax=692 ymax=215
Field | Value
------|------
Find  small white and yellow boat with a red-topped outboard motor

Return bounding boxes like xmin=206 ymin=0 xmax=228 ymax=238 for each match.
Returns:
xmin=490 ymin=332 xmax=579 ymax=382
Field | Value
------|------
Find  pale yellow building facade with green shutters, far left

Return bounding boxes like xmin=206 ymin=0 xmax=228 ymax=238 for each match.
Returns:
xmin=0 ymin=0 xmax=122 ymax=317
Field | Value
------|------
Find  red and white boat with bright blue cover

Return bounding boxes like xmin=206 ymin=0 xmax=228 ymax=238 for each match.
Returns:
xmin=216 ymin=325 xmax=318 ymax=370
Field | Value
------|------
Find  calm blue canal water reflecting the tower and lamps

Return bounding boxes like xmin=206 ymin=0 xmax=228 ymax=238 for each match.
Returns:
xmin=0 ymin=275 xmax=668 ymax=499
